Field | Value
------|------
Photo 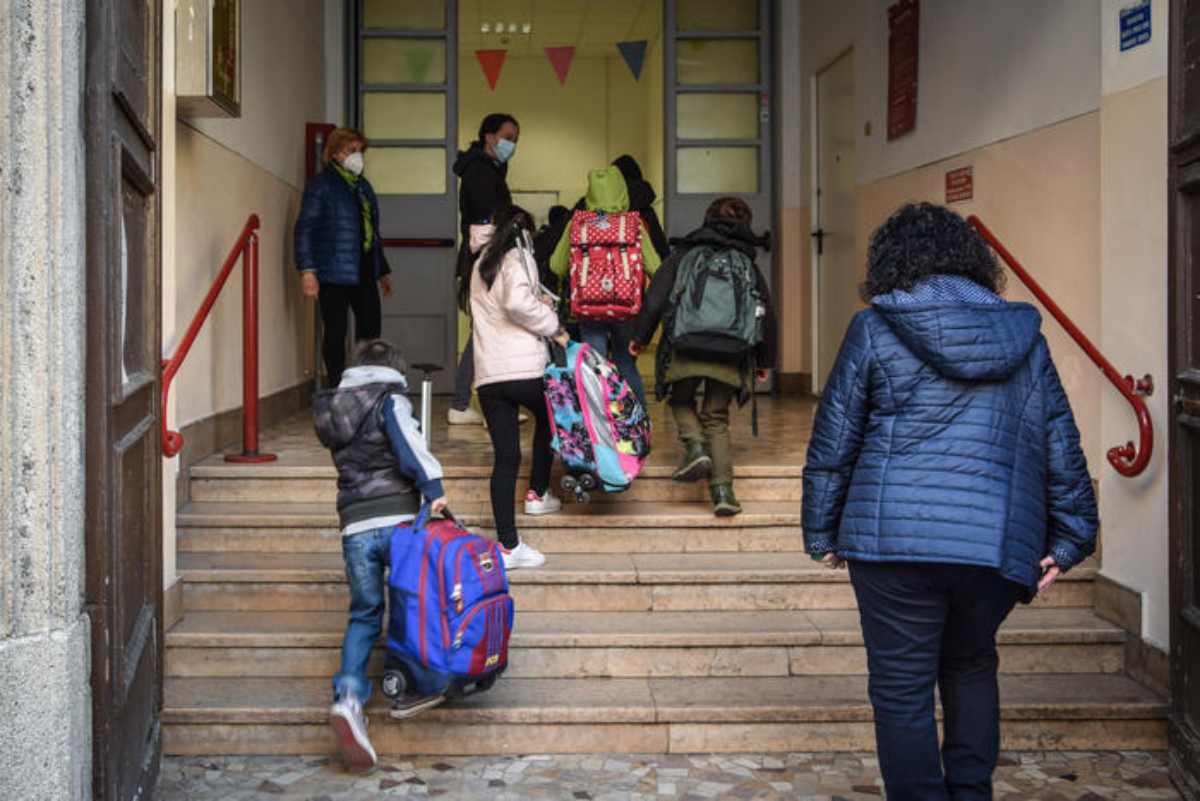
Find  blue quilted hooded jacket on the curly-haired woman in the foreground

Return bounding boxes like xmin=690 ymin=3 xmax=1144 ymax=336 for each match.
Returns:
xmin=804 ymin=276 xmax=1099 ymax=598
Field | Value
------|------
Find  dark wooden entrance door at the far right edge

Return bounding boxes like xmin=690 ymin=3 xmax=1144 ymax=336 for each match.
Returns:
xmin=1168 ymin=0 xmax=1200 ymax=799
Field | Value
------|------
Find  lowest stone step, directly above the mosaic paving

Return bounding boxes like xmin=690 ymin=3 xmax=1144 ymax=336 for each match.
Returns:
xmin=162 ymin=674 xmax=1166 ymax=755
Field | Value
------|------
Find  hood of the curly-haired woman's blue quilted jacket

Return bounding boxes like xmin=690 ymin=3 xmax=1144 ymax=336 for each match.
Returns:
xmin=871 ymin=276 xmax=1042 ymax=381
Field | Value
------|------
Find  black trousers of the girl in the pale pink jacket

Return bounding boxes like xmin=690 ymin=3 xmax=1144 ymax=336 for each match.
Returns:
xmin=478 ymin=378 xmax=554 ymax=548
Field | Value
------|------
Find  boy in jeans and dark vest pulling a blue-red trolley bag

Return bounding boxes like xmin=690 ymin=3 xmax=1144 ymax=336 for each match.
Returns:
xmin=313 ymin=339 xmax=446 ymax=767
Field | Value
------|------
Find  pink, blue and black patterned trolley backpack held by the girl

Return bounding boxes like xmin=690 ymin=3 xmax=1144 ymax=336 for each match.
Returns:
xmin=544 ymin=342 xmax=650 ymax=502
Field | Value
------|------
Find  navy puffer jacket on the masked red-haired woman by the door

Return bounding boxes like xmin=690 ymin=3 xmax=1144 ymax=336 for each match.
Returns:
xmin=295 ymin=165 xmax=391 ymax=287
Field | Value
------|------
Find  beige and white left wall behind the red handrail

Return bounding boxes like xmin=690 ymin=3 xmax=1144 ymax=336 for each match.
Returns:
xmin=162 ymin=0 xmax=326 ymax=586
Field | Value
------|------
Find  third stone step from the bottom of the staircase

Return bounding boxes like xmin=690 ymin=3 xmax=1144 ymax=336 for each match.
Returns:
xmin=178 ymin=553 xmax=1096 ymax=612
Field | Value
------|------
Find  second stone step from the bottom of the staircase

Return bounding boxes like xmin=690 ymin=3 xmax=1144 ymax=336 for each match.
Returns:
xmin=167 ymin=609 xmax=1126 ymax=679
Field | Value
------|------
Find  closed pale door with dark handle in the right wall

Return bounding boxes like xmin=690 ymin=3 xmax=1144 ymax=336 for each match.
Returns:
xmin=812 ymin=50 xmax=862 ymax=393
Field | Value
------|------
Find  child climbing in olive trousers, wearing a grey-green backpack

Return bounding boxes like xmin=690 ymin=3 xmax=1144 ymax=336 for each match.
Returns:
xmin=629 ymin=197 xmax=776 ymax=517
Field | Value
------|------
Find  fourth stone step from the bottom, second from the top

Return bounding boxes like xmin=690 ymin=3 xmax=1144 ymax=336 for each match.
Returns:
xmin=175 ymin=501 xmax=804 ymax=554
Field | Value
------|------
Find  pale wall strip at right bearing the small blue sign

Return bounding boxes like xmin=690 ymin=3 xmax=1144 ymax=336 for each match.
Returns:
xmin=1093 ymin=0 xmax=1171 ymax=649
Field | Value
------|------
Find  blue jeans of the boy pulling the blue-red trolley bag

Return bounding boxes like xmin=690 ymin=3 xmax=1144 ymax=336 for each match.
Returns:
xmin=334 ymin=526 xmax=394 ymax=704
